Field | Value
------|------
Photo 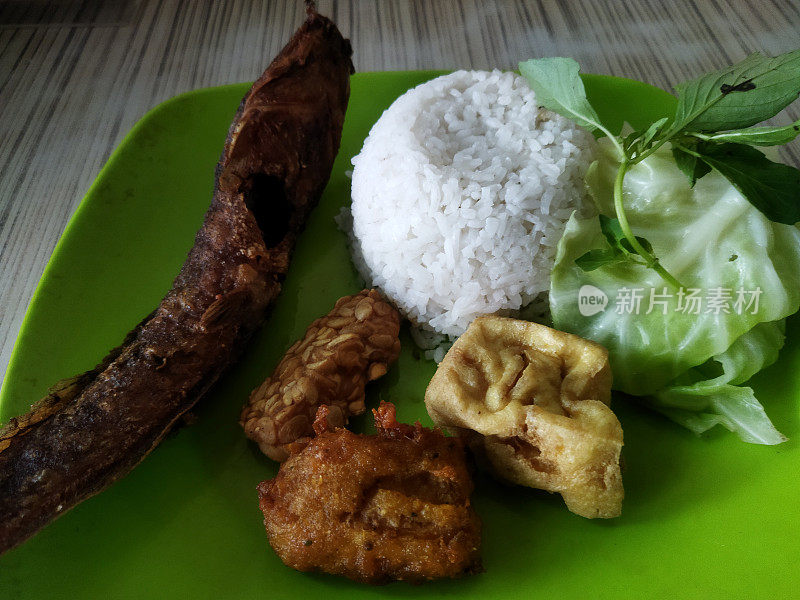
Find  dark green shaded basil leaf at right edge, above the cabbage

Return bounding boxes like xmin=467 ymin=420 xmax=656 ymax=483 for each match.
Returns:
xmin=697 ymin=143 xmax=800 ymax=225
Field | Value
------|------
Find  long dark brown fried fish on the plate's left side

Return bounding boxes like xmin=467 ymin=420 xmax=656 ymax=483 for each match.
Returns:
xmin=0 ymin=7 xmax=353 ymax=553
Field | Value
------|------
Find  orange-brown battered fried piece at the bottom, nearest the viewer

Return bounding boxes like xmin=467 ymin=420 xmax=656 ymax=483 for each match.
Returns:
xmin=258 ymin=403 xmax=481 ymax=584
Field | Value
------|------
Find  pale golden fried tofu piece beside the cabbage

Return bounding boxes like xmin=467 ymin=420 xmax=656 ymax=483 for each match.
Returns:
xmin=425 ymin=317 xmax=624 ymax=518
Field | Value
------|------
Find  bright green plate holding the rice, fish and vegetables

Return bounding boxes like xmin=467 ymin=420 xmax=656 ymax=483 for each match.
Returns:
xmin=0 ymin=72 xmax=800 ymax=600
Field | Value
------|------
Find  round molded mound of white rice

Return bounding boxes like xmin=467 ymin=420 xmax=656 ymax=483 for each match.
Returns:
xmin=340 ymin=70 xmax=594 ymax=345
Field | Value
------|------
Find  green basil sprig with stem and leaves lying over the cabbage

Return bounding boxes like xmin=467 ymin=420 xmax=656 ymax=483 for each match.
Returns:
xmin=519 ymin=50 xmax=800 ymax=288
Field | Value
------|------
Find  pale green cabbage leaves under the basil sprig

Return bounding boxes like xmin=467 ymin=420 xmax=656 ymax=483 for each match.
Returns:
xmin=550 ymin=141 xmax=800 ymax=443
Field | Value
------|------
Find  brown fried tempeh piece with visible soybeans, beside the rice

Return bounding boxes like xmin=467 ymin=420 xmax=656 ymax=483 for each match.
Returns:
xmin=240 ymin=290 xmax=400 ymax=460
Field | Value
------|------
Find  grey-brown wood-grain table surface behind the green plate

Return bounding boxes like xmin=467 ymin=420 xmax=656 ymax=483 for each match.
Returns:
xmin=0 ymin=0 xmax=800 ymax=392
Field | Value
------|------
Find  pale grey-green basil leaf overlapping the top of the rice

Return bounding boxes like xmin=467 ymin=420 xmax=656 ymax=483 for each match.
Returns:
xmin=519 ymin=57 xmax=602 ymax=131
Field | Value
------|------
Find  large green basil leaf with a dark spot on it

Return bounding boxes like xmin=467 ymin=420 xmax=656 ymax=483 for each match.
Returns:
xmin=673 ymin=50 xmax=800 ymax=131
